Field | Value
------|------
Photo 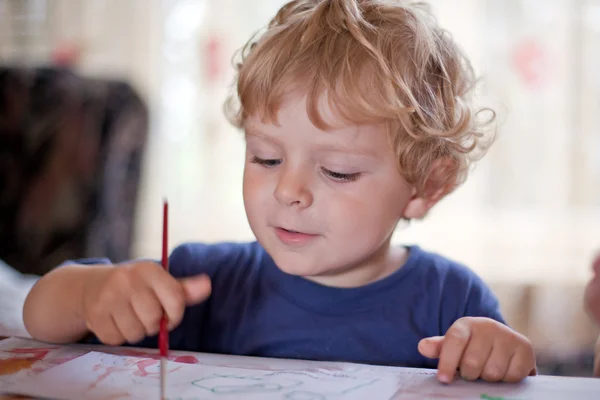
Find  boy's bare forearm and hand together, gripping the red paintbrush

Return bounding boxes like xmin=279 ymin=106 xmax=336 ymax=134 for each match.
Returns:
xmin=23 ymin=262 xmax=211 ymax=345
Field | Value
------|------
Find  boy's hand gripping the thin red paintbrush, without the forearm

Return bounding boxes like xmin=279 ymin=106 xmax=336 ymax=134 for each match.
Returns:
xmin=82 ymin=262 xmax=211 ymax=346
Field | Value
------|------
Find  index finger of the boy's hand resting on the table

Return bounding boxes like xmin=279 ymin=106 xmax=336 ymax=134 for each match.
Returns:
xmin=438 ymin=320 xmax=471 ymax=383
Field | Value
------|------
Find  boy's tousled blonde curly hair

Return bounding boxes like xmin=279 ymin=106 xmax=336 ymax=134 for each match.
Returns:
xmin=226 ymin=0 xmax=495 ymax=194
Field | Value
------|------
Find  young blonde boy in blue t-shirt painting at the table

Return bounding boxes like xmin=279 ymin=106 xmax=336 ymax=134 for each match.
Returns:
xmin=24 ymin=0 xmax=536 ymax=388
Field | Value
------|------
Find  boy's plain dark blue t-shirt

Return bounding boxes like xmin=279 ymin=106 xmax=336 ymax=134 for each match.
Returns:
xmin=81 ymin=242 xmax=504 ymax=368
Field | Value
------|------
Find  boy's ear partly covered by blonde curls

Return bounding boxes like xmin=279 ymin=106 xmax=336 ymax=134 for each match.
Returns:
xmin=403 ymin=157 xmax=458 ymax=219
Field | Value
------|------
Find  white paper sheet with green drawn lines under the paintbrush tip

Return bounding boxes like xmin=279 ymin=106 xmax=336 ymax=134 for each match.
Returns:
xmin=8 ymin=352 xmax=396 ymax=400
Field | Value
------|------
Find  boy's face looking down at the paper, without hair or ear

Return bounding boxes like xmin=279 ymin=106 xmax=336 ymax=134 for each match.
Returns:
xmin=244 ymin=98 xmax=415 ymax=286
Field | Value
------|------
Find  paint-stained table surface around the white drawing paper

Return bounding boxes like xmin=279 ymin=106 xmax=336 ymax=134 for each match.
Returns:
xmin=0 ymin=337 xmax=600 ymax=400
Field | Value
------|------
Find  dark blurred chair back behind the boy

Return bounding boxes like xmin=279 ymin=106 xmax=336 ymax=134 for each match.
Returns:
xmin=0 ymin=67 xmax=148 ymax=275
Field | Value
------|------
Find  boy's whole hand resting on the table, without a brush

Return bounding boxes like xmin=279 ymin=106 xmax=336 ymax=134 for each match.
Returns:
xmin=419 ymin=317 xmax=536 ymax=383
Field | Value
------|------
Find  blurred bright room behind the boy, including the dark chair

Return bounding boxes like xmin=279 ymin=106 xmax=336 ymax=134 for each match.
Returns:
xmin=0 ymin=0 xmax=600 ymax=375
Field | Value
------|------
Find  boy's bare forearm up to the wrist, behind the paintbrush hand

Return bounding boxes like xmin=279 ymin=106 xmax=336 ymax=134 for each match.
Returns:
xmin=23 ymin=265 xmax=113 ymax=343
